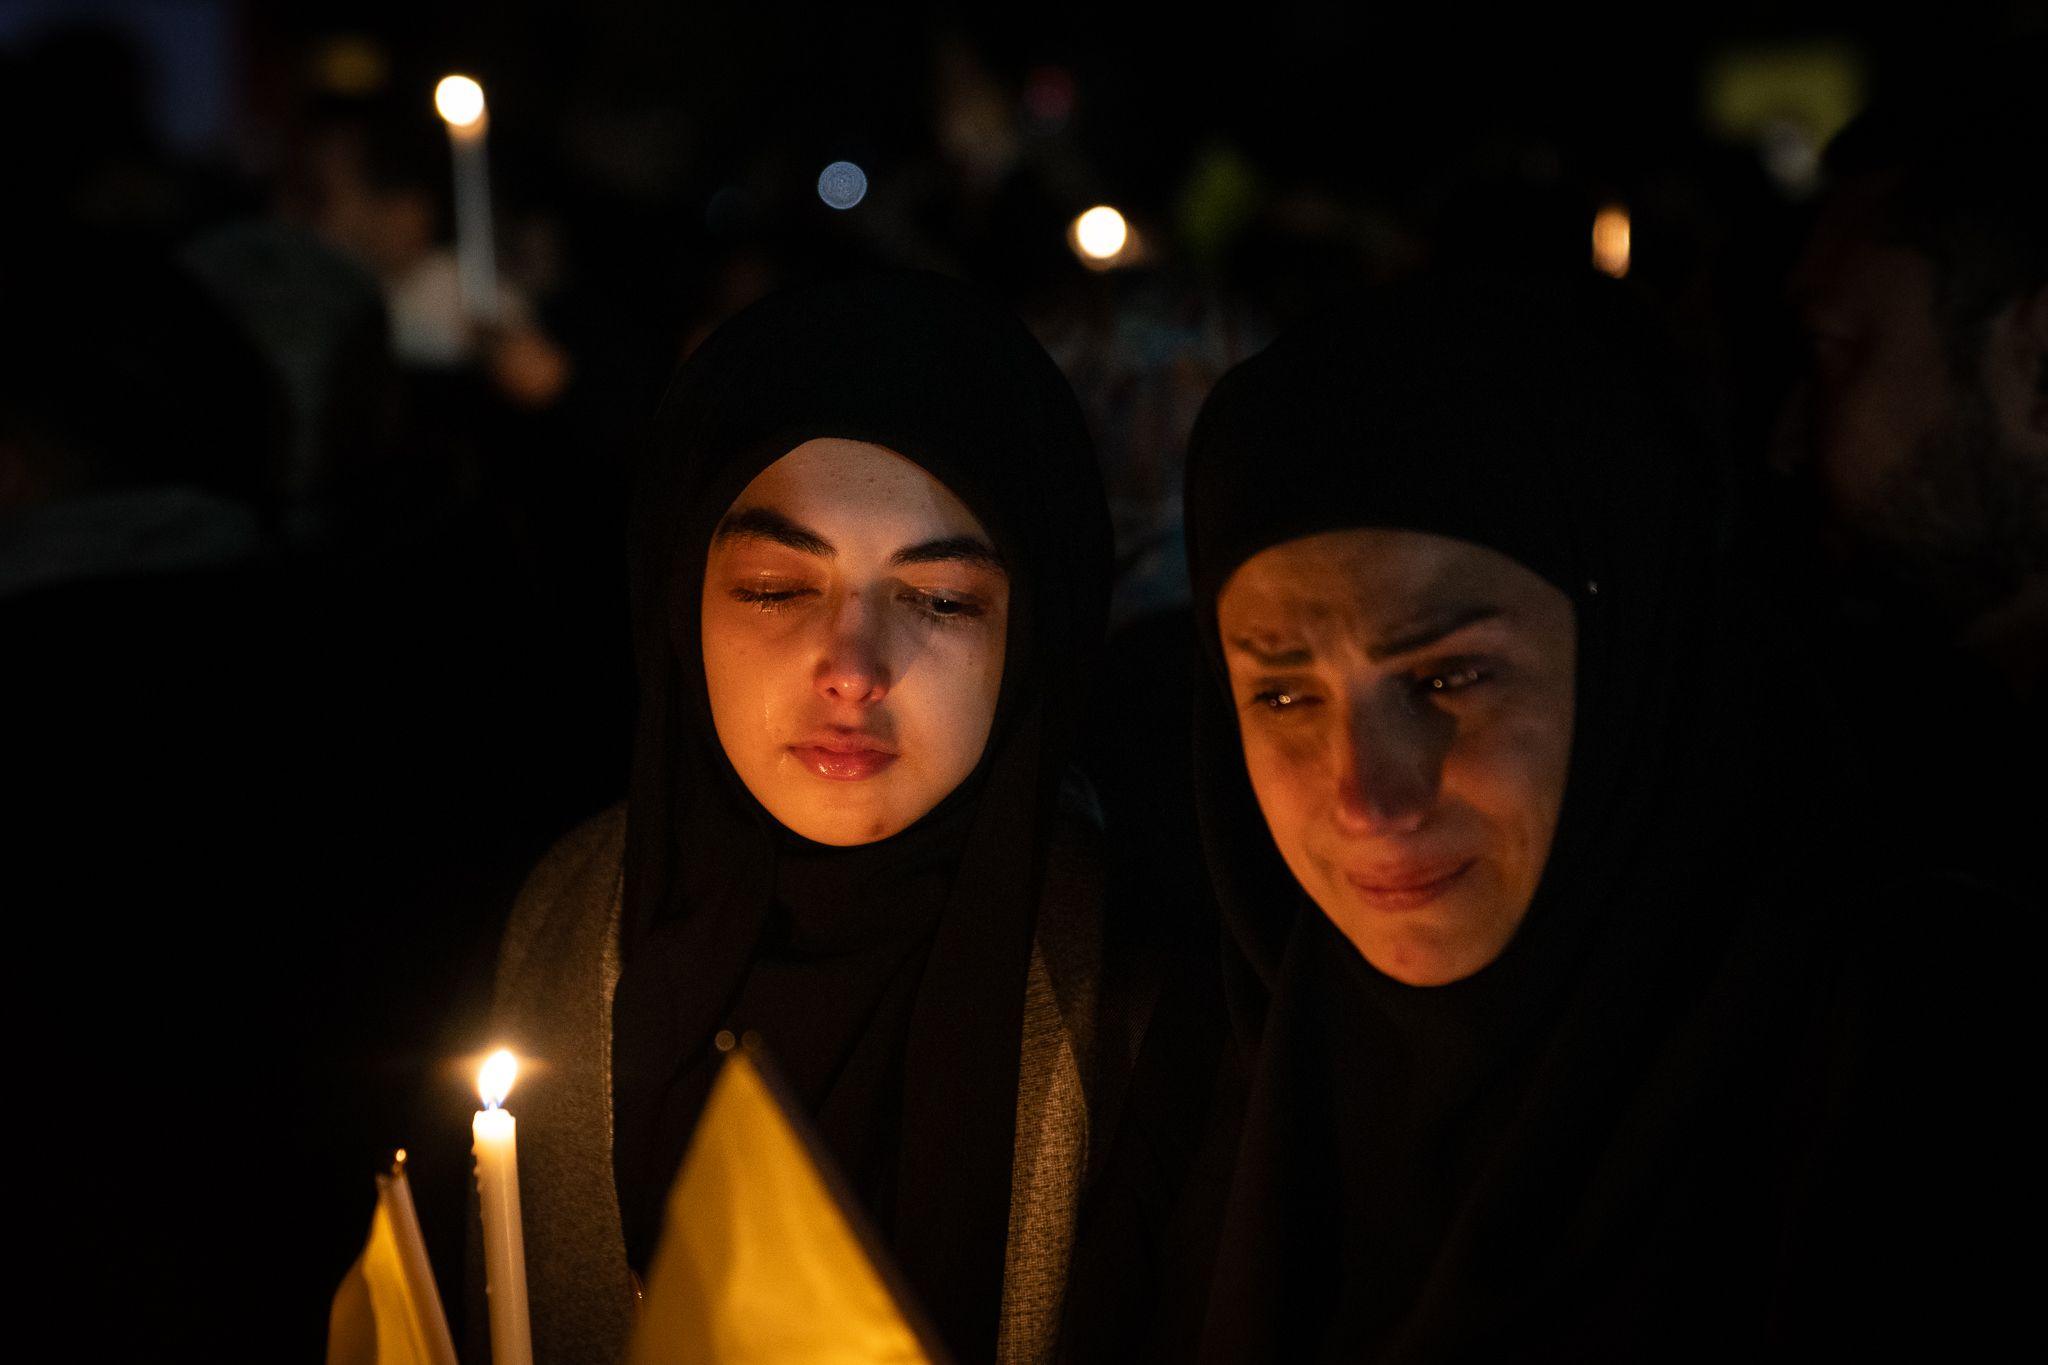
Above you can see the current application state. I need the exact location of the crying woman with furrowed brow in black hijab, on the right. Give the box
[1122,280,1998,1361]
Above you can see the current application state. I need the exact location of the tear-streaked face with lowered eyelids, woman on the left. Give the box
[702,438,1010,845]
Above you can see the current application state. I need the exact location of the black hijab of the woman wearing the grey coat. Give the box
[612,274,1110,1359]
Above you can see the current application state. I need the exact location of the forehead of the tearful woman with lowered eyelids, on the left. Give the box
[729,436,985,538]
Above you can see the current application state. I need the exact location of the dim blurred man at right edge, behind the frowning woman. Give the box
[1782,72,2048,905]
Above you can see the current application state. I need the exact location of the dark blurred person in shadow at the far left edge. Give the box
[0,235,321,1359]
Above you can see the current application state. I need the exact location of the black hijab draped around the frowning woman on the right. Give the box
[1188,278,1875,1361]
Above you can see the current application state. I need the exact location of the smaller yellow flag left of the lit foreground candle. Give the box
[328,1152,455,1365]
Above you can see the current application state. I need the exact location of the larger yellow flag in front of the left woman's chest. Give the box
[629,1048,934,1365]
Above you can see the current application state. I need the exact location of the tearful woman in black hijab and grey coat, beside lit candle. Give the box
[479,274,1110,1361]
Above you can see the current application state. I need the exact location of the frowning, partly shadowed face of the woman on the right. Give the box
[1217,530,1577,986]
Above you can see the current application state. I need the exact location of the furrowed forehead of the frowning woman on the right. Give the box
[1217,528,1563,630]
